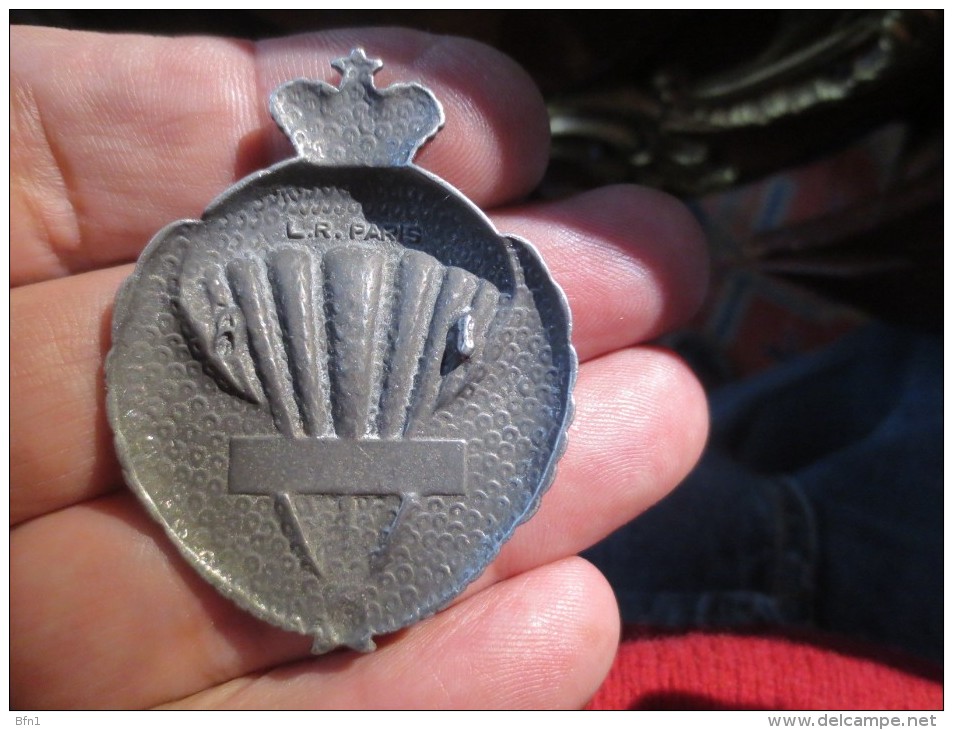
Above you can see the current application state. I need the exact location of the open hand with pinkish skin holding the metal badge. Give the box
[10,27,707,708]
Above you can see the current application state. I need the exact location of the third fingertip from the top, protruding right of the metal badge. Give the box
[468,349,708,594]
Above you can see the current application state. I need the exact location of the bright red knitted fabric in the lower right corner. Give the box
[589,633,943,710]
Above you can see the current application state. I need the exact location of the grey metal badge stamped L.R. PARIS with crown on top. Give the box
[106,49,576,653]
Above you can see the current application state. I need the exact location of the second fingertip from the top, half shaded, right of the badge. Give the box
[494,185,708,352]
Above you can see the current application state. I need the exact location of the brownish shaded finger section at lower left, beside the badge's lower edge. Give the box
[10,492,309,709]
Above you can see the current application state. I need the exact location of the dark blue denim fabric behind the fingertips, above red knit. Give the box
[586,325,943,662]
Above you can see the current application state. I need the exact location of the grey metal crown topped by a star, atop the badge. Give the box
[271,48,444,167]
